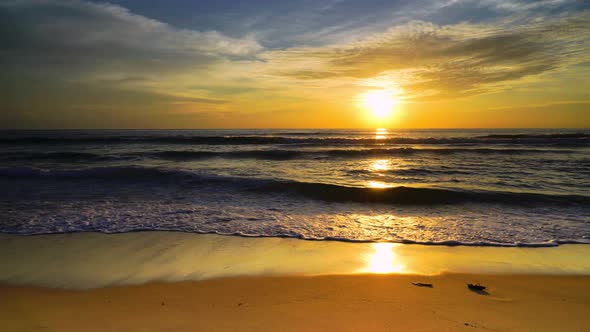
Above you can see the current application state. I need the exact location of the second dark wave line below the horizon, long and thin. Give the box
[0,148,575,162]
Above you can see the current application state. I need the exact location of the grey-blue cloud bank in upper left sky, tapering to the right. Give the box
[0,0,262,85]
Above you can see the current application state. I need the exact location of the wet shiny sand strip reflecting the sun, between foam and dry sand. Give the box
[0,231,590,289]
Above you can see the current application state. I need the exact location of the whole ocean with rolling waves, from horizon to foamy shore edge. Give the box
[0,129,590,246]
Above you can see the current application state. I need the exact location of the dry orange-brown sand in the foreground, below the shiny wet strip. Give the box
[0,274,590,332]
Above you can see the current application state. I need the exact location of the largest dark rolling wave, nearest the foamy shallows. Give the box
[0,166,590,206]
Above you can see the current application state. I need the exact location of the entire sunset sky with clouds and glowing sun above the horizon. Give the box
[0,0,590,129]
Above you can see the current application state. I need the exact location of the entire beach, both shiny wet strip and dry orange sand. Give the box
[0,232,590,331]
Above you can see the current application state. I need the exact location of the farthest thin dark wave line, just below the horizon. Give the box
[0,133,590,146]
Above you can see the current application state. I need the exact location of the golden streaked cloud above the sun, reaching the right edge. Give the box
[264,11,590,99]
